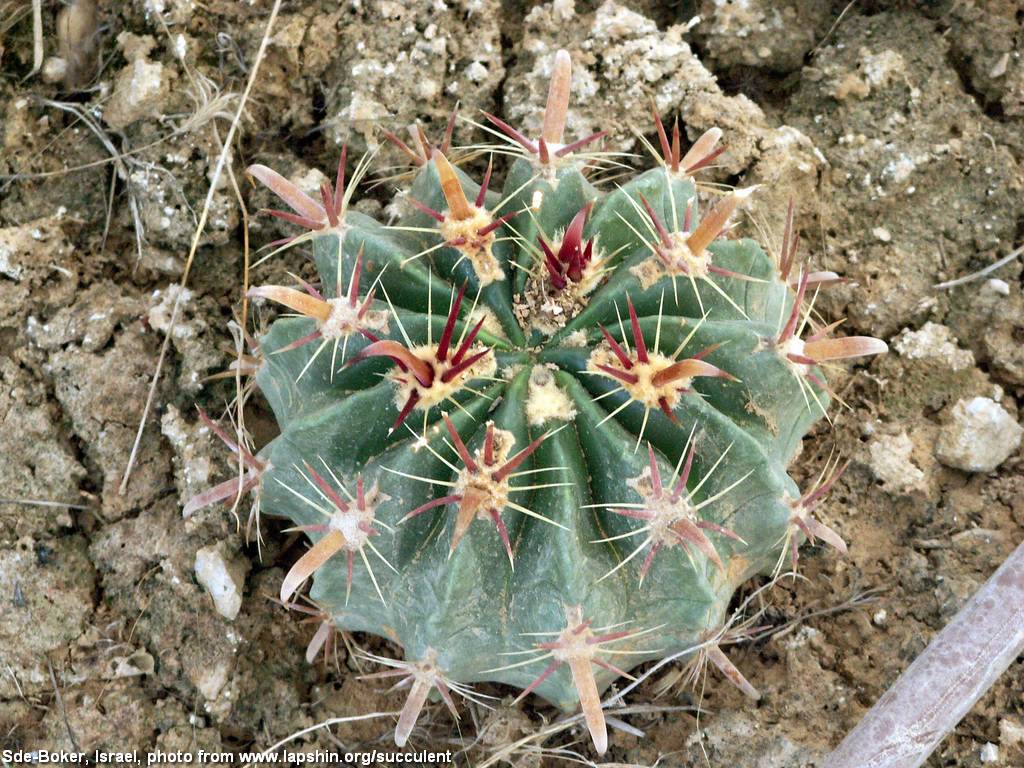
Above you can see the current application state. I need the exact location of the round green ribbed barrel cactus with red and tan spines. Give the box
[190,51,886,753]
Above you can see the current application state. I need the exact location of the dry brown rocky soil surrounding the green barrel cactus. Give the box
[0,0,1024,768]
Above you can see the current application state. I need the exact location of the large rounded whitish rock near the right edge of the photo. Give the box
[935,397,1024,472]
